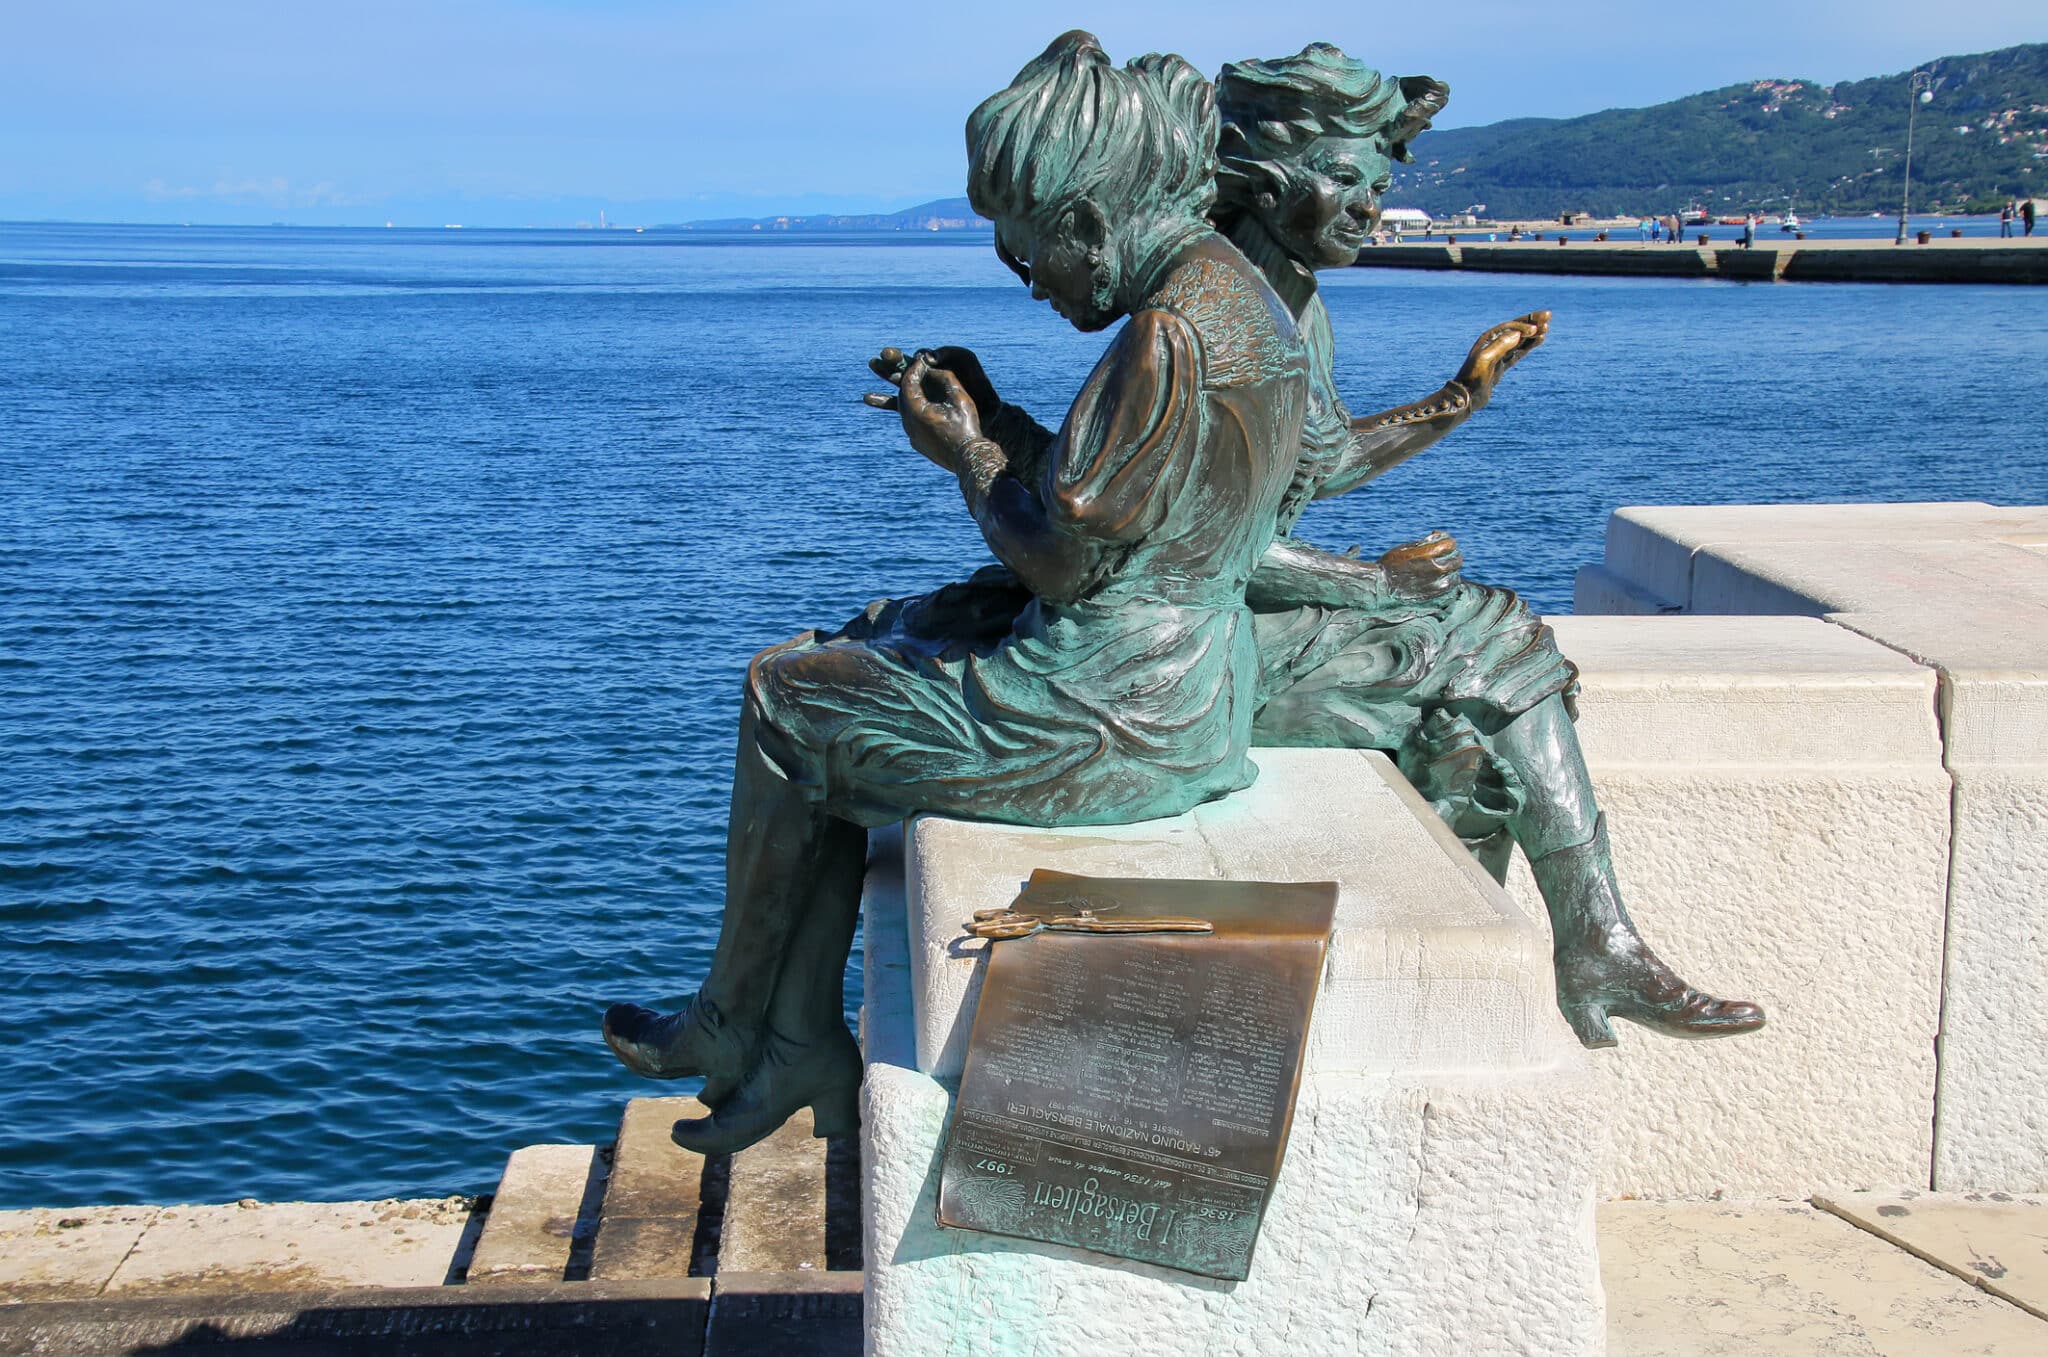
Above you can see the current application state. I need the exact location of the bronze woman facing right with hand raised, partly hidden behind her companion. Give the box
[1217,43,1763,1046]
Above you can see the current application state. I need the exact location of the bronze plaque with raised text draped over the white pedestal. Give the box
[938,870,1337,1281]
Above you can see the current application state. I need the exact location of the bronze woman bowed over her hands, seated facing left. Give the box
[604,33,1307,1152]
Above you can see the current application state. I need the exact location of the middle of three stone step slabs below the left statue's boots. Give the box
[590,1097,727,1281]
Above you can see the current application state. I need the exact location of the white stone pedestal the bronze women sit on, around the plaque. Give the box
[862,749,1606,1357]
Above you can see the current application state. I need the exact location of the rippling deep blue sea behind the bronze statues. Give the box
[0,225,2048,1208]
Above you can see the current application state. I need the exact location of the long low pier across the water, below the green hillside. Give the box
[1358,231,2048,284]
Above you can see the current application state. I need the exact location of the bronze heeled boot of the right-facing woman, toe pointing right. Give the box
[1530,815,1763,1048]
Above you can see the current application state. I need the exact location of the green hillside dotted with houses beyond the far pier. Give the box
[1386,43,2048,217]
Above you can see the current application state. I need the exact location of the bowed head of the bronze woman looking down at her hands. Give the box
[967,33,1217,330]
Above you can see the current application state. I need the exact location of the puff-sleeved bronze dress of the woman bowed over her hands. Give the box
[748,233,1307,827]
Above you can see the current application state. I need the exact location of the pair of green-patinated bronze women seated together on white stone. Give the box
[604,33,1763,1152]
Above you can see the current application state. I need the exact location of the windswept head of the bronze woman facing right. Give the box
[1217,43,1450,268]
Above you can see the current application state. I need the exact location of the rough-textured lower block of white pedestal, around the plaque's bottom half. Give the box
[862,1064,1606,1357]
